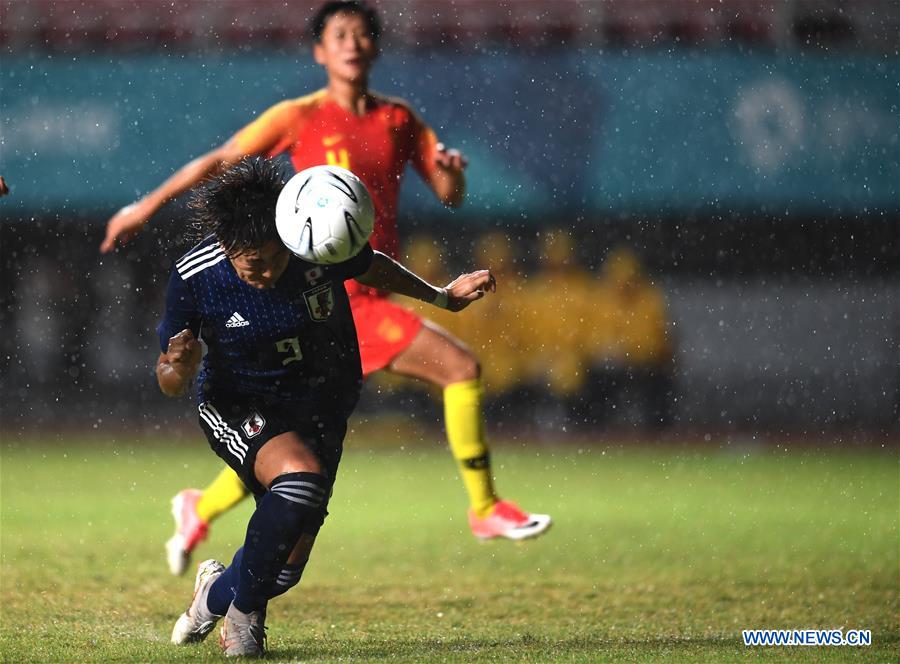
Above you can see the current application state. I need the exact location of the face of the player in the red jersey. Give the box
[313,12,378,82]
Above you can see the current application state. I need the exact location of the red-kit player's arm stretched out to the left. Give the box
[100,103,289,254]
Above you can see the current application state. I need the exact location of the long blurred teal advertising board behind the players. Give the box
[0,50,900,220]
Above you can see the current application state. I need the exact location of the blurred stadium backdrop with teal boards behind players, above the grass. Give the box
[0,0,900,441]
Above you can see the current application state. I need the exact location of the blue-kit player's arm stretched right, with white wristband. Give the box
[356,251,497,311]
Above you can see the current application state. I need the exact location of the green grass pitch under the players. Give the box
[0,436,900,662]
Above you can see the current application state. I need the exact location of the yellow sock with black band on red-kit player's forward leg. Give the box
[444,379,497,517]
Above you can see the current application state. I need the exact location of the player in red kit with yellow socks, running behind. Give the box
[101,0,550,574]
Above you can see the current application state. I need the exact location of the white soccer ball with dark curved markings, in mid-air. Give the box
[275,166,375,265]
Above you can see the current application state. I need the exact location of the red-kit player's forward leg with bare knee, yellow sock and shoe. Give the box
[388,321,550,540]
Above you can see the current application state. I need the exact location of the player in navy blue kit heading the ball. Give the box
[156,158,495,656]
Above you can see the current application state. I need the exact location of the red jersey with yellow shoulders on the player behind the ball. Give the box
[235,89,437,294]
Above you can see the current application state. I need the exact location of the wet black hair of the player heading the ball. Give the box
[188,157,285,256]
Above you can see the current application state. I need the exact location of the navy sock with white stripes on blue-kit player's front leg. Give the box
[232,473,328,613]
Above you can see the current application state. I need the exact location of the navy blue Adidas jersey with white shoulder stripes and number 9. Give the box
[157,237,373,419]
